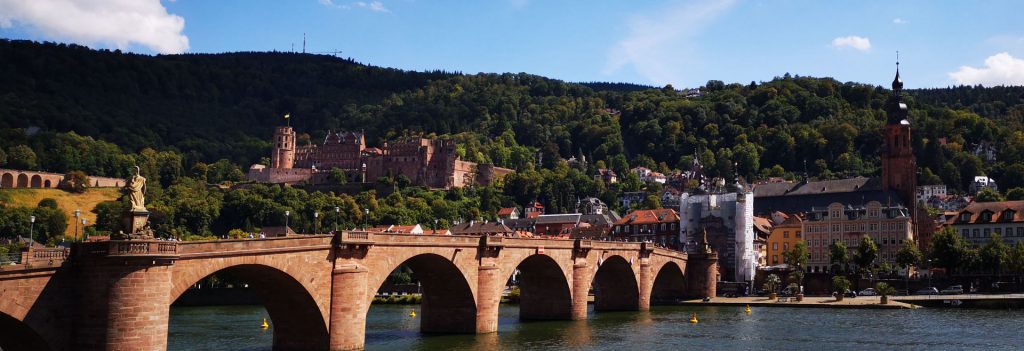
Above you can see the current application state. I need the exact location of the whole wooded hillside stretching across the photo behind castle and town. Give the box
[0,41,1024,195]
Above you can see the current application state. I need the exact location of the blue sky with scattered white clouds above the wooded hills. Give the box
[0,0,1024,88]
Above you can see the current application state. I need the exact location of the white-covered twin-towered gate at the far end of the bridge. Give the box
[679,186,760,281]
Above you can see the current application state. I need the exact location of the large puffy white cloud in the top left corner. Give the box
[0,0,188,53]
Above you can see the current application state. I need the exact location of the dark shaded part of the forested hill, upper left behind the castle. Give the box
[0,40,451,162]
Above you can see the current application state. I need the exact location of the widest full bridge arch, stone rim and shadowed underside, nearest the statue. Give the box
[168,260,330,350]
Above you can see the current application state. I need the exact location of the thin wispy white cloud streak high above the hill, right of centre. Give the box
[603,0,734,84]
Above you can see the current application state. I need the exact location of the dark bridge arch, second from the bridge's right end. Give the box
[591,255,640,311]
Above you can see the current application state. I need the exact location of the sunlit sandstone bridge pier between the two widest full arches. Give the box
[330,264,370,351]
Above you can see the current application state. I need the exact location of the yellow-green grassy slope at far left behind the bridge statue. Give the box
[0,187,121,240]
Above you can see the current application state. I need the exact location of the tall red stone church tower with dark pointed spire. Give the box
[882,61,918,214]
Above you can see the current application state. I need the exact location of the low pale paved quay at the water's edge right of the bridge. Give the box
[679,296,918,309]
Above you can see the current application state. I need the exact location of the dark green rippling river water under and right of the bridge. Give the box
[168,305,1024,351]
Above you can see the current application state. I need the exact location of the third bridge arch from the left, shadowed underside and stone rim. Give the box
[369,253,476,334]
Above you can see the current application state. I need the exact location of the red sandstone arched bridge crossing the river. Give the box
[0,232,717,351]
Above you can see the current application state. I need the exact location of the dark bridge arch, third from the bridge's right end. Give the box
[502,254,572,320]
